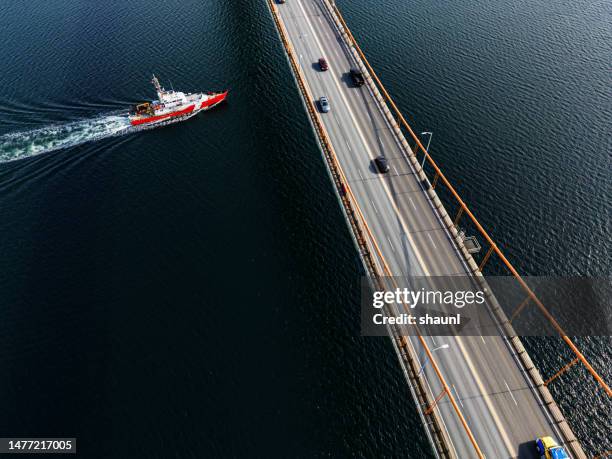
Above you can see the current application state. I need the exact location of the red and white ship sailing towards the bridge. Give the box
[129,75,227,126]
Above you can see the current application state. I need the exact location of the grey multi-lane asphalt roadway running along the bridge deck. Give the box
[276,0,561,458]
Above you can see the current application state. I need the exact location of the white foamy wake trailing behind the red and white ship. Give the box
[0,115,136,163]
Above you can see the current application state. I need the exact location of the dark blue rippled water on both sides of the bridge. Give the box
[0,0,612,458]
